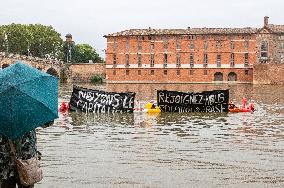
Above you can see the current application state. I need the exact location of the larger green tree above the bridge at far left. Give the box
[0,24,63,58]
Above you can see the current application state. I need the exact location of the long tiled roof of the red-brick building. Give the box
[104,27,258,38]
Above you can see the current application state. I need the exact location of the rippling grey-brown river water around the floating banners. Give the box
[36,84,284,188]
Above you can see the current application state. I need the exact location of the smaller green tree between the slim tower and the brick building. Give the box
[75,44,104,63]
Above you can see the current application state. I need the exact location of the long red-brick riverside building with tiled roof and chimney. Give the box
[104,17,284,83]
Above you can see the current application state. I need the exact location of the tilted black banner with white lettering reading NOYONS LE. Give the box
[70,86,135,113]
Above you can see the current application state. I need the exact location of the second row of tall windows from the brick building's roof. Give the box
[113,53,249,67]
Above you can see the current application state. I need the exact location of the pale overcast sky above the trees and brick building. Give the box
[0,0,284,55]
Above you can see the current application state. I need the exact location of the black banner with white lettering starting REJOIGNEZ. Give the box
[157,90,229,112]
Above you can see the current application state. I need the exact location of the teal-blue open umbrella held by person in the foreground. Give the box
[0,62,58,139]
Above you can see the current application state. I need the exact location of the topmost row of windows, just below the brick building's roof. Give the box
[113,40,249,52]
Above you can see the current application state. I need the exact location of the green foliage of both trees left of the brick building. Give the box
[0,23,104,63]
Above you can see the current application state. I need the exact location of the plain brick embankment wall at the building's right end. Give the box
[253,63,284,84]
